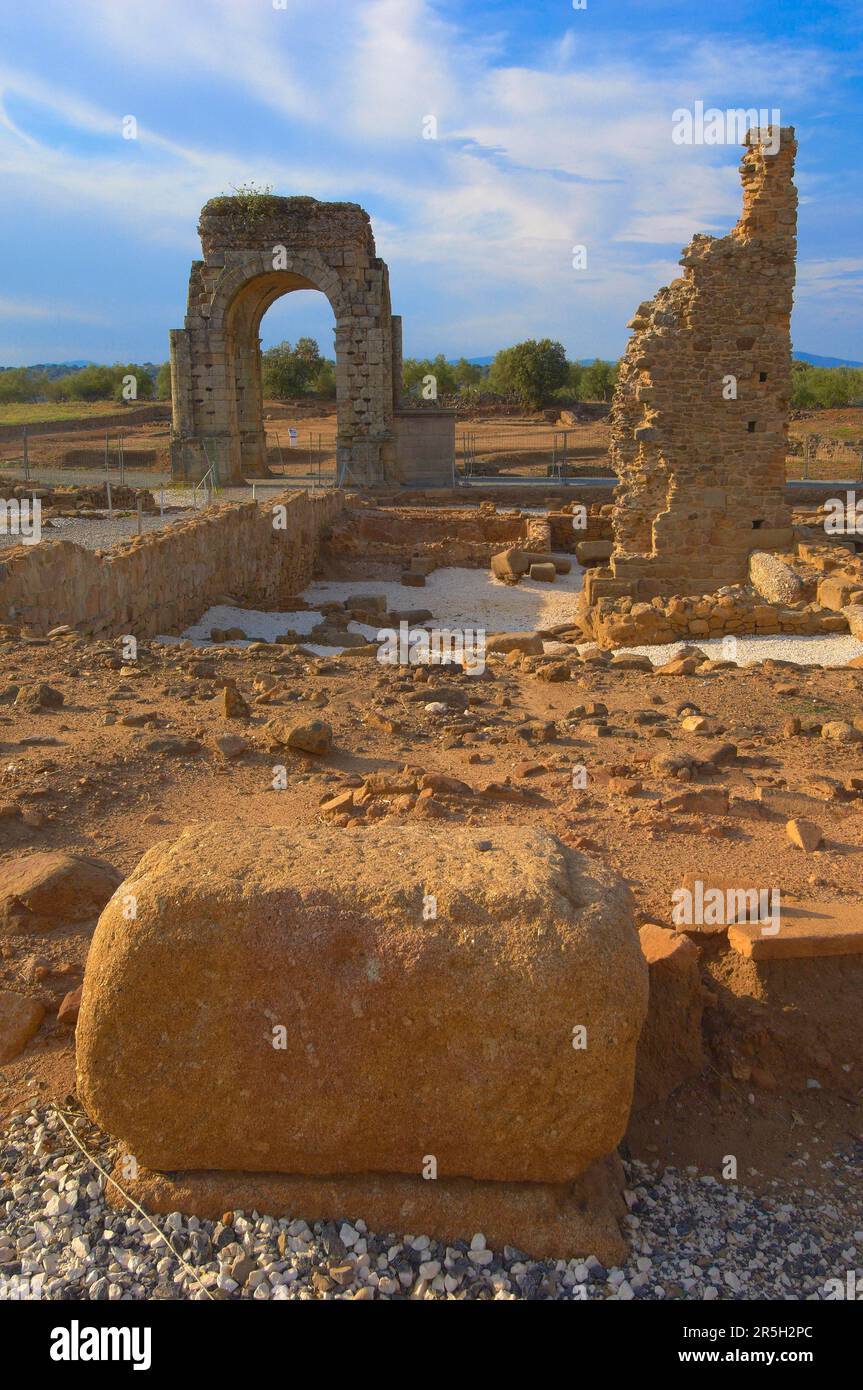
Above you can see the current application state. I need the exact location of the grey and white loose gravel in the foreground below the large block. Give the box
[0,1106,863,1301]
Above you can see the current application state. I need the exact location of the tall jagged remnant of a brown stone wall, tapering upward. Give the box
[585,126,796,603]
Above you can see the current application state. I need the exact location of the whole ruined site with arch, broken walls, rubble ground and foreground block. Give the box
[0,113,863,1302]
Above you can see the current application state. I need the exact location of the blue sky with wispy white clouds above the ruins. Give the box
[0,0,863,366]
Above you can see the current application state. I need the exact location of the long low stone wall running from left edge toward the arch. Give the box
[0,492,345,638]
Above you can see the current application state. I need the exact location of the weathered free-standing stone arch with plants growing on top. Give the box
[171,195,402,485]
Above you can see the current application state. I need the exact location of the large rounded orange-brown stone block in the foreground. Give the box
[78,824,646,1183]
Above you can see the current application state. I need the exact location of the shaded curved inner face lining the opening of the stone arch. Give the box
[225,270,345,478]
